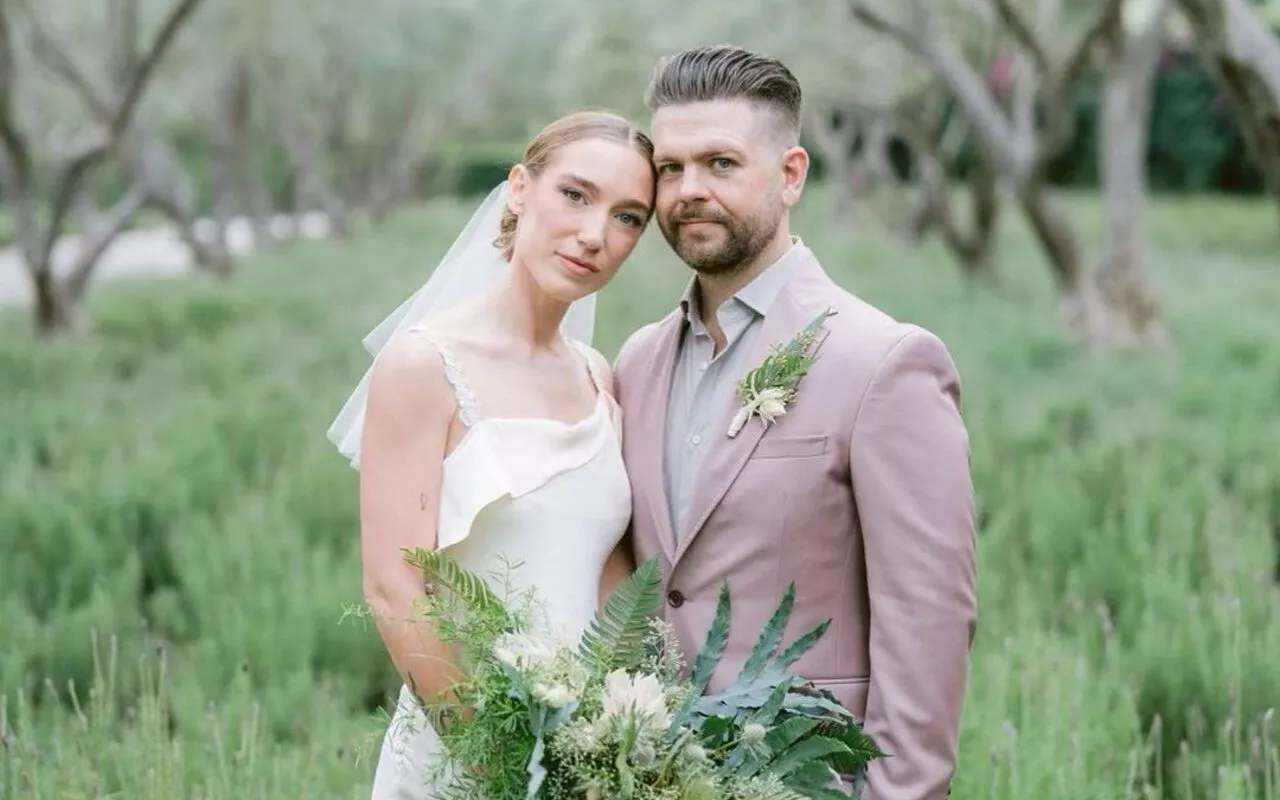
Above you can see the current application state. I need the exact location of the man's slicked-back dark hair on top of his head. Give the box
[645,45,801,143]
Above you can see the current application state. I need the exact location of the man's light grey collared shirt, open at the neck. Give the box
[662,238,808,543]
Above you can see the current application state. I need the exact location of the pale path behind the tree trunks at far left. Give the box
[0,214,329,307]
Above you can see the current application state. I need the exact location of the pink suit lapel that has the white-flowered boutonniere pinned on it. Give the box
[662,288,829,567]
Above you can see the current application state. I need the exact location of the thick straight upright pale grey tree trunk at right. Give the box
[1097,5,1167,346]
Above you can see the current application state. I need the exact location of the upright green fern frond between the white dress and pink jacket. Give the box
[579,556,662,673]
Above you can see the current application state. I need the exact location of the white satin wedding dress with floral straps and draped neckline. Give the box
[372,326,631,800]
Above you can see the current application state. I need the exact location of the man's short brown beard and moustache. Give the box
[662,204,782,275]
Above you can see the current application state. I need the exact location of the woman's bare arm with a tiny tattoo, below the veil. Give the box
[360,335,458,701]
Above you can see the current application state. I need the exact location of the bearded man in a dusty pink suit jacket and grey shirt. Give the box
[614,46,977,800]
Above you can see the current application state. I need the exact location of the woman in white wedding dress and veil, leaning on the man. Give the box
[329,111,655,800]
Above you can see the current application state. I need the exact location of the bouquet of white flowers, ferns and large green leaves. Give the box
[396,549,882,800]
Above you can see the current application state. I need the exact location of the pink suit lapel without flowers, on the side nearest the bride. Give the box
[635,311,684,561]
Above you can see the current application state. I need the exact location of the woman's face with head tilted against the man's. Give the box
[511,138,654,302]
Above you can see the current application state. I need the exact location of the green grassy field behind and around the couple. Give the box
[0,186,1280,800]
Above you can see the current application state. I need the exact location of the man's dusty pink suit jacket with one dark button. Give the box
[614,248,977,800]
